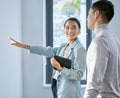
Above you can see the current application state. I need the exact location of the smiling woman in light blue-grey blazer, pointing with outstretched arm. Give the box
[9,18,86,98]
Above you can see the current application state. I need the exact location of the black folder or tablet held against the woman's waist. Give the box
[54,55,72,69]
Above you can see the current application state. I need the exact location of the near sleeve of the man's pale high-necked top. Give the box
[84,38,109,98]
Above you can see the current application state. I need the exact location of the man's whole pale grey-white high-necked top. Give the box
[84,24,120,98]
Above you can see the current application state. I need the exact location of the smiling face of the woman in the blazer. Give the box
[65,20,80,41]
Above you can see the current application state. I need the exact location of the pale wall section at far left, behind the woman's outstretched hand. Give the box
[0,0,22,98]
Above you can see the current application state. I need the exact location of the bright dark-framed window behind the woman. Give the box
[45,0,91,84]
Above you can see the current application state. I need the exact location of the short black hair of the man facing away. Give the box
[91,0,114,22]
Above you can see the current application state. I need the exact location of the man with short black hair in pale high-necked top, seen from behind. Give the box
[84,0,120,98]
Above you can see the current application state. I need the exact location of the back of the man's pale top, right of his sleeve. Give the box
[100,27,120,98]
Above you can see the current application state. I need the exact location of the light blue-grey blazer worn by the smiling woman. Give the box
[30,39,86,98]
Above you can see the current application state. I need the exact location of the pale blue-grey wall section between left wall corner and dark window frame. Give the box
[22,0,52,98]
